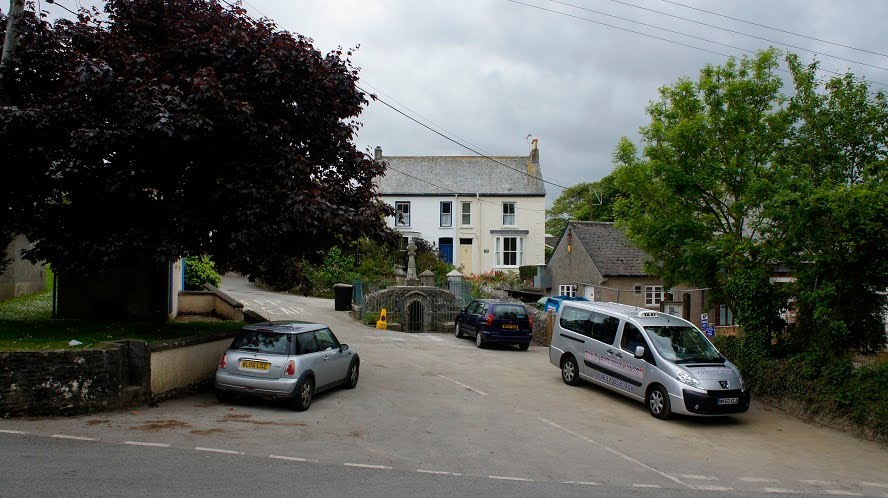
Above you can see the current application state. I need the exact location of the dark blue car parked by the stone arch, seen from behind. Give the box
[454,299,533,351]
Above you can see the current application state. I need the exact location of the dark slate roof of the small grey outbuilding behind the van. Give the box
[562,221,650,277]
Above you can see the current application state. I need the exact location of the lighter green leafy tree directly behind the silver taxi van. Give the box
[614,49,792,354]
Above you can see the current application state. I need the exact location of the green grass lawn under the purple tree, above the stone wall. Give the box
[0,271,244,350]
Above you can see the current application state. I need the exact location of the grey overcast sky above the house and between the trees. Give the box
[44,0,888,204]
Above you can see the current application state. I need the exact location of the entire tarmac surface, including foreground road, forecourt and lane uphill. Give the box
[0,276,888,496]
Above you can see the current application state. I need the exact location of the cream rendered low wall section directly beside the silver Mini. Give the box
[150,332,237,401]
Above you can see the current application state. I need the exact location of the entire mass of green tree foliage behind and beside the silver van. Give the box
[613,49,888,357]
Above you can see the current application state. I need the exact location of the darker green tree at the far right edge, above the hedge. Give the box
[767,56,888,353]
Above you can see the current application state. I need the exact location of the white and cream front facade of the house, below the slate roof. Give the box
[381,195,546,274]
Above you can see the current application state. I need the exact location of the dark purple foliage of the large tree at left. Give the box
[0,0,390,276]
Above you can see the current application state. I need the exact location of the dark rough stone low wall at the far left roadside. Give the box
[0,346,127,417]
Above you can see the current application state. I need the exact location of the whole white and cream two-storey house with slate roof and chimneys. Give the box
[376,140,546,274]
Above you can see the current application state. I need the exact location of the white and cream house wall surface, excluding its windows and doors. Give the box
[382,195,546,274]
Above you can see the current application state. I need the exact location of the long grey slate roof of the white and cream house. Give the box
[376,156,546,196]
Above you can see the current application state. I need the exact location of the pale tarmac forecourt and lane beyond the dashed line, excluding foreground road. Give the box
[0,276,888,496]
